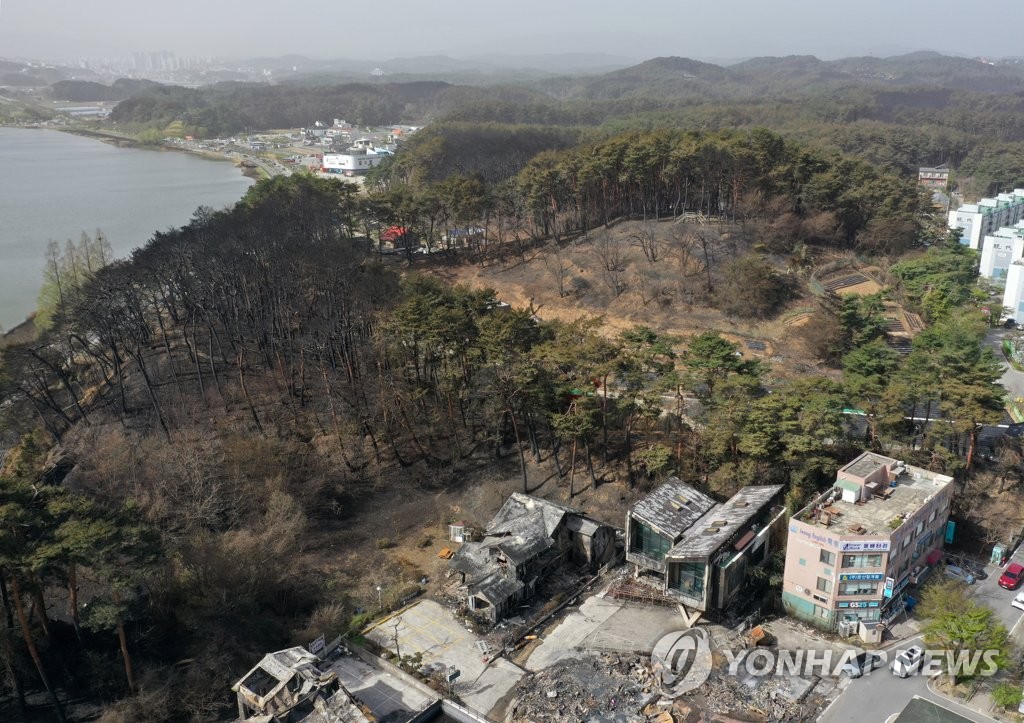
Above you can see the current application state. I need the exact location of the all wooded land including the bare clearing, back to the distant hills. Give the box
[6,49,1024,723]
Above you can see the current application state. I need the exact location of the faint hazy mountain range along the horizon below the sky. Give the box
[8,51,1024,100]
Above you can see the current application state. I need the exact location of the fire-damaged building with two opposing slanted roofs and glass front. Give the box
[626,478,784,611]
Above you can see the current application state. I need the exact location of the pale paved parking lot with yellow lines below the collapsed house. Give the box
[367,600,524,714]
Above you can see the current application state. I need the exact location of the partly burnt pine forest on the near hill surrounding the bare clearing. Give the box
[0,132,1001,721]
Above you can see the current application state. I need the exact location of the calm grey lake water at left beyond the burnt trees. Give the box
[0,128,252,329]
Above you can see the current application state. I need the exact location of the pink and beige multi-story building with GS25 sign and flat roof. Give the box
[782,452,953,632]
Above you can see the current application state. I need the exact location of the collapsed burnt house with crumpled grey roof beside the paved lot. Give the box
[449,493,615,623]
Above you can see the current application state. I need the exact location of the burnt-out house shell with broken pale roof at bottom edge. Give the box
[231,647,369,723]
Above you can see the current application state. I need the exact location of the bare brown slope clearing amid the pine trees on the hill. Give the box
[431,221,820,378]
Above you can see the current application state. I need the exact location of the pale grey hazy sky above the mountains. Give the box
[0,0,1024,59]
